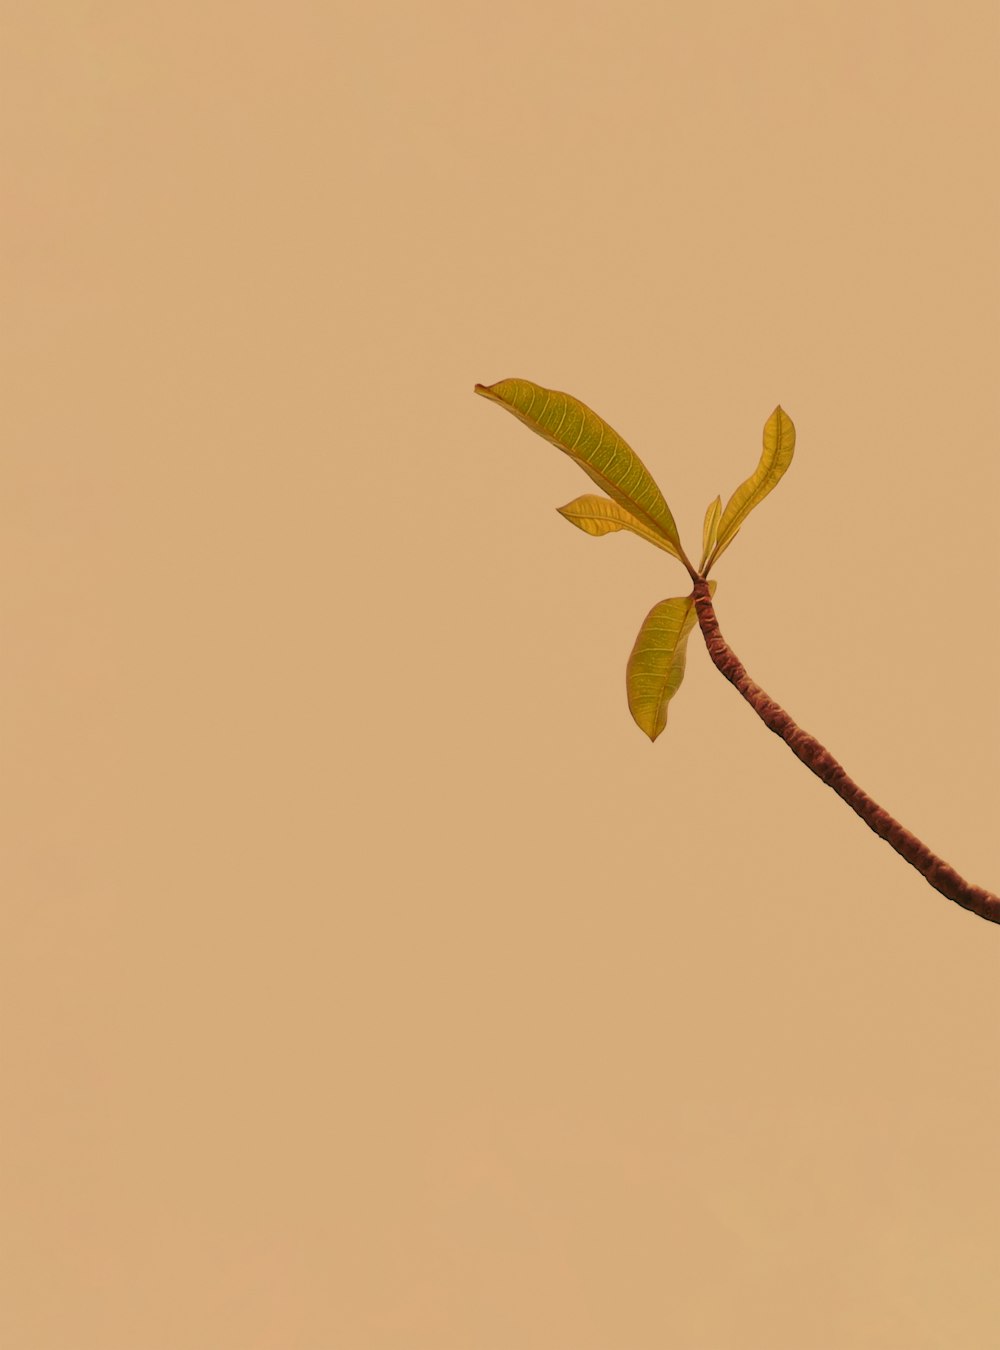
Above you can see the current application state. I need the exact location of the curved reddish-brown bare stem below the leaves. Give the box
[694,579,1000,923]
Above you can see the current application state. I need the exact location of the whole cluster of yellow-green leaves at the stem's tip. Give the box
[475,379,795,741]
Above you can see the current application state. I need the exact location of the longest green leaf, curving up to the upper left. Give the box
[475,379,686,562]
